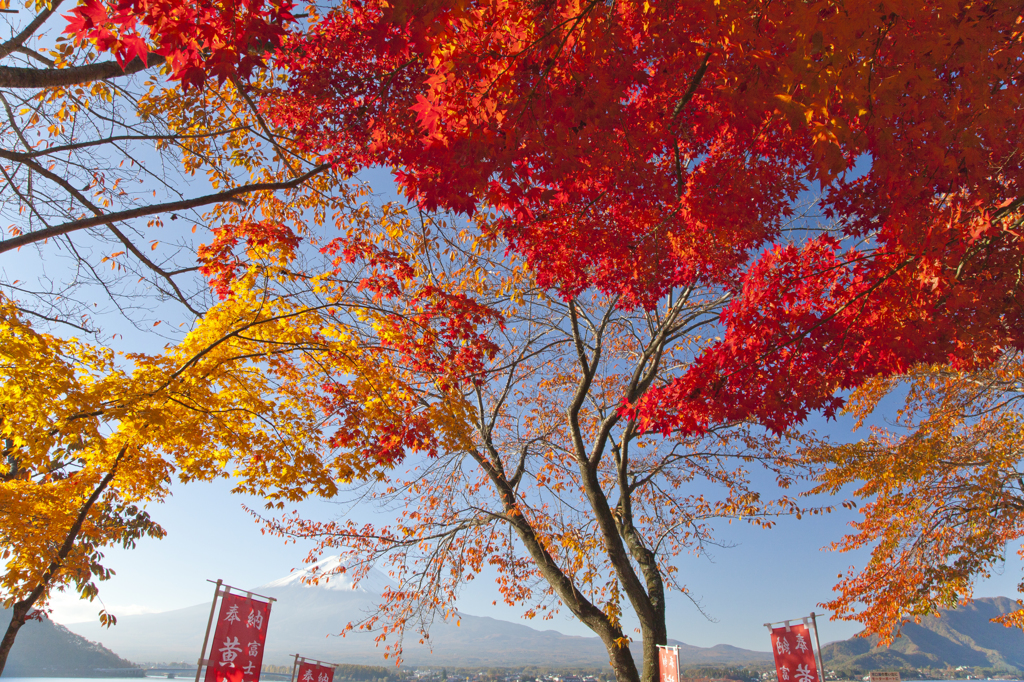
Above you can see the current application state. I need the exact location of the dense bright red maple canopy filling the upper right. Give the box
[64,0,1024,431]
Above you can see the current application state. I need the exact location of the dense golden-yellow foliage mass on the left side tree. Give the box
[0,290,380,607]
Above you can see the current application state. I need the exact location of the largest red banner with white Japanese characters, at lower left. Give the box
[206,593,270,682]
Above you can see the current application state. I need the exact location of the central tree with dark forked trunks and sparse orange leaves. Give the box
[253,215,820,680]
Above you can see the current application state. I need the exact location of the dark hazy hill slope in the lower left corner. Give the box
[0,610,139,677]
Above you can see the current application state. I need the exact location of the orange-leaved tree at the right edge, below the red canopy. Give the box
[807,351,1024,643]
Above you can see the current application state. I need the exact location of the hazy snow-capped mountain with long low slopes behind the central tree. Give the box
[69,560,771,667]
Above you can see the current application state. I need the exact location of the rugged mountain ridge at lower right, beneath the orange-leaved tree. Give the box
[821,597,1024,673]
